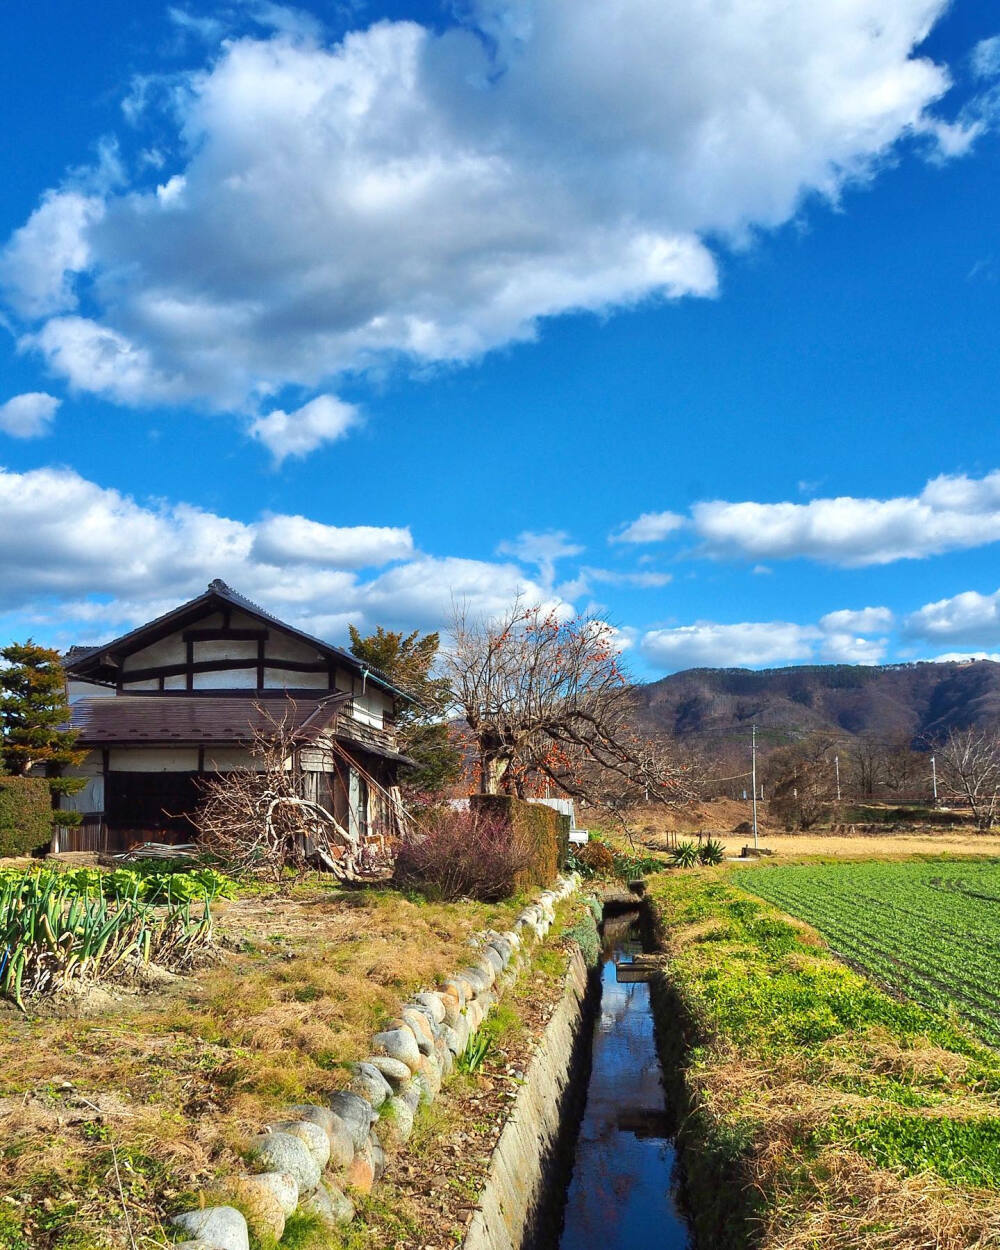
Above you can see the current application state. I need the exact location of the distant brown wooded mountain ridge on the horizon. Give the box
[636,660,1000,743]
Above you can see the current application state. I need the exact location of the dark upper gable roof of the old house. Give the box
[63,578,416,703]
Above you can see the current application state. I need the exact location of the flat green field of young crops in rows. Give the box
[735,860,1000,1046]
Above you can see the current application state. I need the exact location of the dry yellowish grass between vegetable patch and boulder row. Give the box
[0,884,515,1250]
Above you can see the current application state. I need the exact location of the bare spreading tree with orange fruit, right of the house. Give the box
[448,600,686,805]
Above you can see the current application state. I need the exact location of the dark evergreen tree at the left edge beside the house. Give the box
[0,639,86,825]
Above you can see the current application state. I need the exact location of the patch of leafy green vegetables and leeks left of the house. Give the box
[0,869,234,1010]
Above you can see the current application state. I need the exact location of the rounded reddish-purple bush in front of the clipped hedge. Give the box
[395,808,533,903]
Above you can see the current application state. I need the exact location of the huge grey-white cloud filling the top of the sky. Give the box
[0,0,954,435]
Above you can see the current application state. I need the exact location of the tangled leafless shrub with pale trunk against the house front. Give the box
[194,715,395,881]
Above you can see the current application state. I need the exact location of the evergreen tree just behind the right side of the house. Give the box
[350,625,463,794]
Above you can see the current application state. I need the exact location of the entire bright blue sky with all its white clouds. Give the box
[0,0,1000,678]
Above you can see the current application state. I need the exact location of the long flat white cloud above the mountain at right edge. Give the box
[691,470,1000,568]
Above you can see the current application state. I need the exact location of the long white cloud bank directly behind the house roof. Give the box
[0,469,558,636]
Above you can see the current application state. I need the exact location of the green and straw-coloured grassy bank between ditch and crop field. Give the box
[650,870,1000,1250]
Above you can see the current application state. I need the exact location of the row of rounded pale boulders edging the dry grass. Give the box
[173,876,586,1250]
